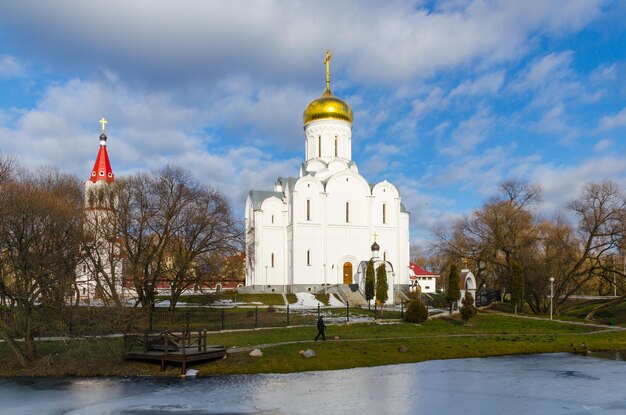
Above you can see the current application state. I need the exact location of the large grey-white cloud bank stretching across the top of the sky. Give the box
[0,0,601,84]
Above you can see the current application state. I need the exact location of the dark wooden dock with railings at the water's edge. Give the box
[124,331,226,375]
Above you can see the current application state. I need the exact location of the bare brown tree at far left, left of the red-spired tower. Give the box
[0,169,83,366]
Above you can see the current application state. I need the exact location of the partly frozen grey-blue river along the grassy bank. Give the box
[0,354,626,415]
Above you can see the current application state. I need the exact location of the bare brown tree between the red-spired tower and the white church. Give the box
[118,167,243,308]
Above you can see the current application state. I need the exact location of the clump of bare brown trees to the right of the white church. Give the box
[436,181,626,313]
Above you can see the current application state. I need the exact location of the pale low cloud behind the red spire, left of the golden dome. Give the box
[0,80,300,210]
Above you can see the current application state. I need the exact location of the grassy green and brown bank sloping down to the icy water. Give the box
[0,313,626,377]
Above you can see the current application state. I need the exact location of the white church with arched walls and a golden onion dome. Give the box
[245,52,410,303]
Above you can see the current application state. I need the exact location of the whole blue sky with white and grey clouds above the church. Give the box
[0,0,626,250]
